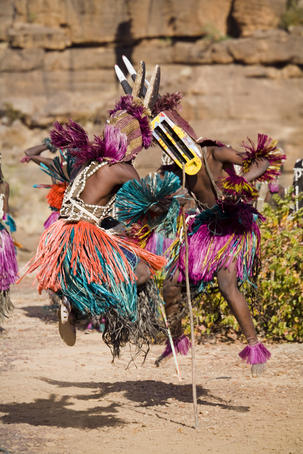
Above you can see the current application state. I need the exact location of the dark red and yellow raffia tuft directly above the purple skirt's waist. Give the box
[218,169,258,201]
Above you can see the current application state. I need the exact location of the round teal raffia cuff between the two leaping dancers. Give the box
[116,172,181,233]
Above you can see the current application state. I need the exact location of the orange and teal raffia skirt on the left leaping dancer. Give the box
[19,219,166,320]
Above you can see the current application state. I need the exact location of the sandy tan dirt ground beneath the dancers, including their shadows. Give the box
[0,278,303,454]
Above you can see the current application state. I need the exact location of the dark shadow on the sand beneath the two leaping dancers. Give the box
[0,378,249,429]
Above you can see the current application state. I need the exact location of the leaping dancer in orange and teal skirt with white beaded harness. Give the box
[19,64,166,356]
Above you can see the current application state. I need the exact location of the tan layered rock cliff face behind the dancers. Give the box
[0,0,303,188]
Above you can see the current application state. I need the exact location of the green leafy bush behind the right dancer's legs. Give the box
[185,189,303,342]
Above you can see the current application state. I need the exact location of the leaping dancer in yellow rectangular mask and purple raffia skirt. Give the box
[113,57,285,374]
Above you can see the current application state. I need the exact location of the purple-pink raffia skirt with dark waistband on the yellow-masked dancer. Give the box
[179,202,264,284]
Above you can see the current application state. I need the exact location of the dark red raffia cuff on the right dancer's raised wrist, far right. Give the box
[242,134,286,181]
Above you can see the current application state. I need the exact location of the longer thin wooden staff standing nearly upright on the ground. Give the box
[181,164,199,429]
